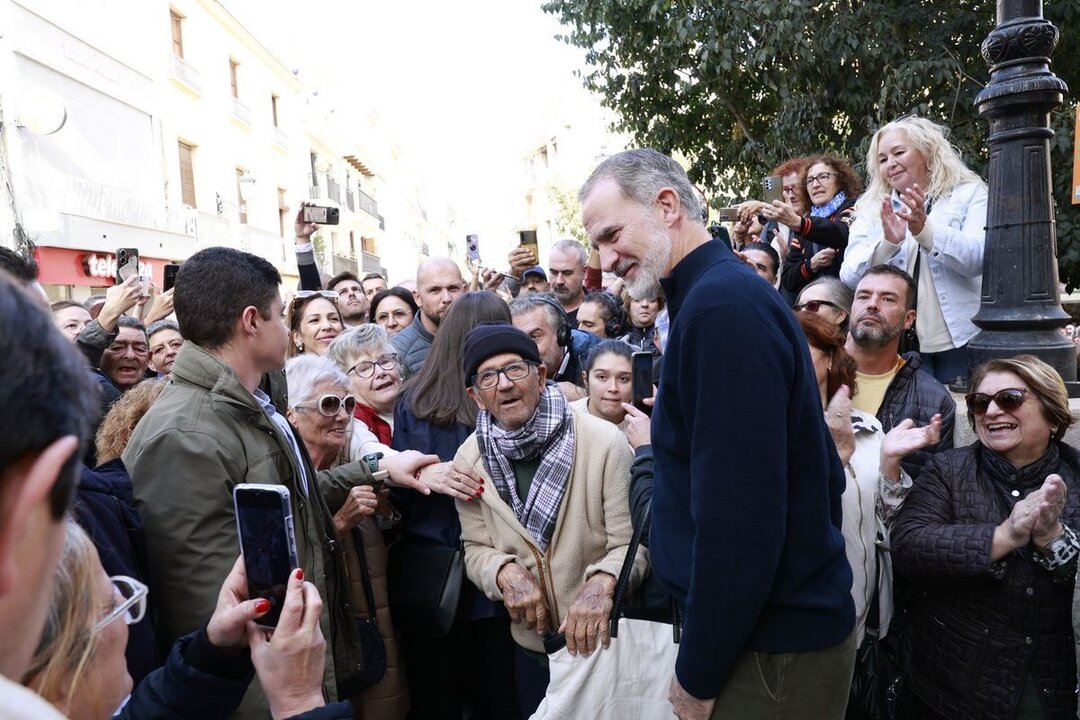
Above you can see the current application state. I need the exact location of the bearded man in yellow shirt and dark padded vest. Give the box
[845,264,956,479]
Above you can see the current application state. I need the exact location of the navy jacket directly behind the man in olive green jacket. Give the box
[75,458,161,684]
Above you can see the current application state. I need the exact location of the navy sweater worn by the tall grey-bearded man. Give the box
[649,241,854,698]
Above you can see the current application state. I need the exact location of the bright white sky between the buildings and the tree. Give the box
[234,0,600,249]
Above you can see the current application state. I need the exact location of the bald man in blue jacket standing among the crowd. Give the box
[390,257,465,377]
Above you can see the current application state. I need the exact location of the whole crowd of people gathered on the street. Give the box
[0,117,1080,720]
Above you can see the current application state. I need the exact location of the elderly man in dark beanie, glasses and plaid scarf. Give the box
[455,323,647,717]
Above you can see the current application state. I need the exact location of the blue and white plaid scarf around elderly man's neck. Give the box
[476,383,575,553]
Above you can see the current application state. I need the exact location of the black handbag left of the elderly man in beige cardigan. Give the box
[387,542,465,638]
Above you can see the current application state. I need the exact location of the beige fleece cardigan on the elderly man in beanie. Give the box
[455,409,648,652]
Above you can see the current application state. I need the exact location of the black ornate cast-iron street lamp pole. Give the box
[968,0,1077,386]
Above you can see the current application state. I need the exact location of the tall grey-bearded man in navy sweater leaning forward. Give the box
[580,150,855,720]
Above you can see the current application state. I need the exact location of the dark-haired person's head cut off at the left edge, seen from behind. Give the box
[0,270,97,720]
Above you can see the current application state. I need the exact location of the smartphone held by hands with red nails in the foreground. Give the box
[232,483,300,627]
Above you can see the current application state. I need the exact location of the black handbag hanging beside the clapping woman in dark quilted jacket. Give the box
[845,551,901,720]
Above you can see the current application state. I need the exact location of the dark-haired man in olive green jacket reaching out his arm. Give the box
[123,247,434,718]
